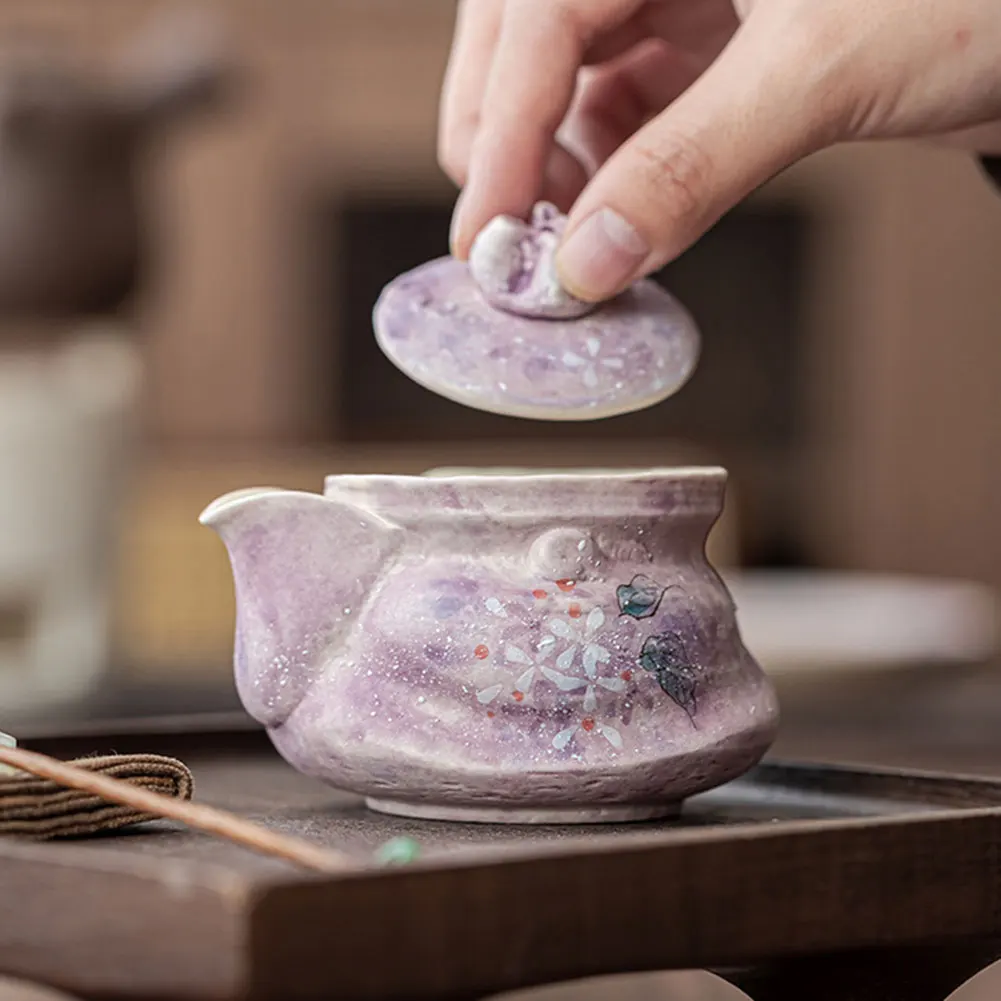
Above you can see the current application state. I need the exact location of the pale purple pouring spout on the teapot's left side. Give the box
[199,487,402,727]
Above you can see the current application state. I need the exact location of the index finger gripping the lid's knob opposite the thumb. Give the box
[453,0,643,255]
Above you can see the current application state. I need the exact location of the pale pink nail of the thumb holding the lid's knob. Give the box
[557,208,650,301]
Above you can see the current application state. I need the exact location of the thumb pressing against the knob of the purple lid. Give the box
[557,11,838,302]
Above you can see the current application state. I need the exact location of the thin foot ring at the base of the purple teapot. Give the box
[365,796,682,825]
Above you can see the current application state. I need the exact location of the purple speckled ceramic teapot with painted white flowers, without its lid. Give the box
[202,468,778,823]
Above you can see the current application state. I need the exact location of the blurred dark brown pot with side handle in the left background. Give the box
[0,10,228,318]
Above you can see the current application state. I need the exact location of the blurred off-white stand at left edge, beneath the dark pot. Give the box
[0,328,142,713]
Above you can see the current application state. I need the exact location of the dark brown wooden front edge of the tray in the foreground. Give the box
[0,744,1001,1001]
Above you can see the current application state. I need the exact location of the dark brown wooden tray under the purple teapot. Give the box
[0,717,1001,1001]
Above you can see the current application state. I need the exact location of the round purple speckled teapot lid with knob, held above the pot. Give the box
[373,209,700,420]
